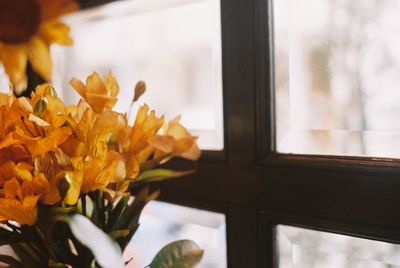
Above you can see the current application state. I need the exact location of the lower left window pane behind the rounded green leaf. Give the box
[124,201,227,268]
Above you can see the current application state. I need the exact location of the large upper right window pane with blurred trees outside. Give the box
[274,0,400,158]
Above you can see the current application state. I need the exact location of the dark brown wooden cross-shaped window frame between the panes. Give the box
[76,0,400,268]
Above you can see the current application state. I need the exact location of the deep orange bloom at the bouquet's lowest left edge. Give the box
[0,178,39,225]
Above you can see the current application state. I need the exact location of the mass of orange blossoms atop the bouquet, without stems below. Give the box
[0,71,200,224]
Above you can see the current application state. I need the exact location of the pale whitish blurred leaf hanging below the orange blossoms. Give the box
[68,214,124,268]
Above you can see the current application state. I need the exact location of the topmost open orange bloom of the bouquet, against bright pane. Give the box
[70,72,119,113]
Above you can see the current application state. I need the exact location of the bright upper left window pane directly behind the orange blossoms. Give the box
[52,0,223,150]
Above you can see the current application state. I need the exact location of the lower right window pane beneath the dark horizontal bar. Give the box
[277,225,400,268]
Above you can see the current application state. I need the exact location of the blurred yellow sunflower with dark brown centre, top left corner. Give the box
[0,0,77,94]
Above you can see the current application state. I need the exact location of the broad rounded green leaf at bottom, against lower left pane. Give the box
[149,240,204,268]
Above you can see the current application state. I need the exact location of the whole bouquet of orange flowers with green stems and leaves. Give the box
[0,73,203,267]
